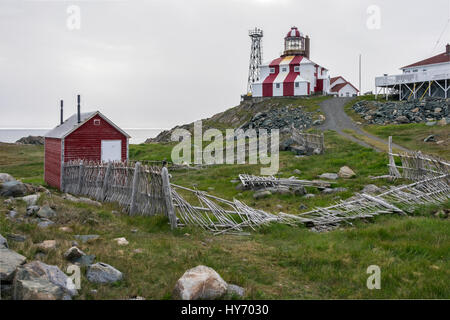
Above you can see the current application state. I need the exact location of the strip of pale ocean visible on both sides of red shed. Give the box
[0,128,164,144]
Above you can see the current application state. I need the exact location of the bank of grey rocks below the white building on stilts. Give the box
[352,97,450,125]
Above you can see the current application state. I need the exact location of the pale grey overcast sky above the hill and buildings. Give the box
[0,0,450,128]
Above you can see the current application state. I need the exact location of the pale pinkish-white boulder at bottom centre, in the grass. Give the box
[173,265,228,300]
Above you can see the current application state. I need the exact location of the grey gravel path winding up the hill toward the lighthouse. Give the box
[318,98,409,152]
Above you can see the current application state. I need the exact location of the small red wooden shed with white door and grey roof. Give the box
[44,111,130,188]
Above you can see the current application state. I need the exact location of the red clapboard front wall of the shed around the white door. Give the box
[64,115,127,161]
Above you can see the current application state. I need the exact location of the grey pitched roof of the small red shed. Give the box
[44,111,130,139]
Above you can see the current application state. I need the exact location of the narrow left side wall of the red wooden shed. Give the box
[44,138,61,188]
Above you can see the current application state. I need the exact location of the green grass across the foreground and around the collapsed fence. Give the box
[0,132,450,299]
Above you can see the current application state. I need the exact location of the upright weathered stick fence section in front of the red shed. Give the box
[61,160,177,228]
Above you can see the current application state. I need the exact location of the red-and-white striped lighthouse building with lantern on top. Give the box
[252,27,330,97]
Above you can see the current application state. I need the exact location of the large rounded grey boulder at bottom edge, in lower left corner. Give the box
[13,261,78,300]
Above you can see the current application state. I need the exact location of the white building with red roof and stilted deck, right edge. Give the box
[375,44,450,100]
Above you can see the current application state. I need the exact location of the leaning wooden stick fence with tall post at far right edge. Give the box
[388,137,450,181]
